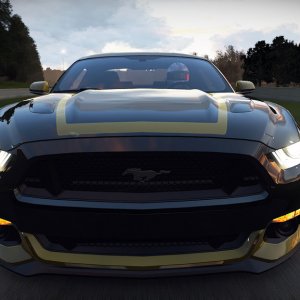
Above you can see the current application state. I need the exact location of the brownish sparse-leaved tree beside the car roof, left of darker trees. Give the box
[213,45,244,86]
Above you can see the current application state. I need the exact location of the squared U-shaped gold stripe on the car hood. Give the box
[56,95,228,136]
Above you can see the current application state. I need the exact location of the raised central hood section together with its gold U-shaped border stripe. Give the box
[56,90,227,136]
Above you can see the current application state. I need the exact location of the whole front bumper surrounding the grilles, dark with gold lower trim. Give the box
[0,138,300,277]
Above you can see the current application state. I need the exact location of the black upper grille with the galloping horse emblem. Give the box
[22,152,264,197]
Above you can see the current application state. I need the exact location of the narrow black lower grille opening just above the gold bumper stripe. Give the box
[37,233,249,256]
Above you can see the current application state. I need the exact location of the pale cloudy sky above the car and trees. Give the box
[10,0,300,69]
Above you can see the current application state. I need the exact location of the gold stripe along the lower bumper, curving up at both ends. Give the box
[24,232,258,268]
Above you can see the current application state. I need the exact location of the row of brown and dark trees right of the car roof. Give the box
[213,36,300,86]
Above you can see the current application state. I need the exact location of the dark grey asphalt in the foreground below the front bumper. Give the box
[0,250,300,300]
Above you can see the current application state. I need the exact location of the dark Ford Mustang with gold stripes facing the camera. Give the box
[0,53,300,277]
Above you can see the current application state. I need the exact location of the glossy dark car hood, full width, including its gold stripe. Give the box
[0,89,299,150]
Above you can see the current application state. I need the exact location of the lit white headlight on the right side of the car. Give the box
[272,142,300,170]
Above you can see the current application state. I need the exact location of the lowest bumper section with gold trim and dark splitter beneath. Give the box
[0,225,300,277]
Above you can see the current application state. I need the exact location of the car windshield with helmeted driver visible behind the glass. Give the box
[52,55,232,93]
